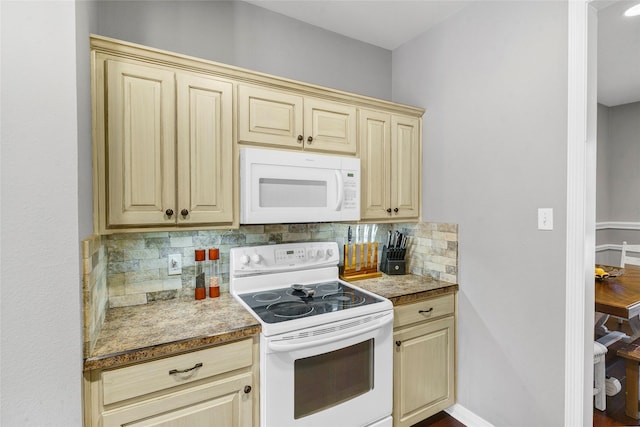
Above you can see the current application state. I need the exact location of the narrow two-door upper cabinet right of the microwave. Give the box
[359,109,422,221]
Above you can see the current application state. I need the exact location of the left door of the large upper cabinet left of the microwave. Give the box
[106,60,176,226]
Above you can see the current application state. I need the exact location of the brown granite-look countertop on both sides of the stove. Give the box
[84,274,458,371]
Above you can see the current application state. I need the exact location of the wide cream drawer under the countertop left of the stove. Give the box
[102,340,253,405]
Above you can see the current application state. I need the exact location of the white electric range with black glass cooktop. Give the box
[229,242,393,427]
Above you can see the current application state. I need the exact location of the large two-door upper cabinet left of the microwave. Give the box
[93,54,234,232]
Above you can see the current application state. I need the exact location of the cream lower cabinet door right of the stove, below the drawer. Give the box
[393,316,455,427]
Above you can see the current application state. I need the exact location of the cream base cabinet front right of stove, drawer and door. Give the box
[393,294,455,427]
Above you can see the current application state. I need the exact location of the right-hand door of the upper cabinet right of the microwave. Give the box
[391,116,422,219]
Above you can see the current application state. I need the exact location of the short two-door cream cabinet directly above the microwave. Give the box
[238,85,357,155]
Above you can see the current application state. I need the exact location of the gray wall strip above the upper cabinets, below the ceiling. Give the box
[98,1,391,100]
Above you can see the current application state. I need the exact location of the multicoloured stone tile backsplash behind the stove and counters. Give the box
[82,222,458,351]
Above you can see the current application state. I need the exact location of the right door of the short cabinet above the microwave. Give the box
[304,98,357,154]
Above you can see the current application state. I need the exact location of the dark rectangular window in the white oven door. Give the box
[294,338,374,419]
